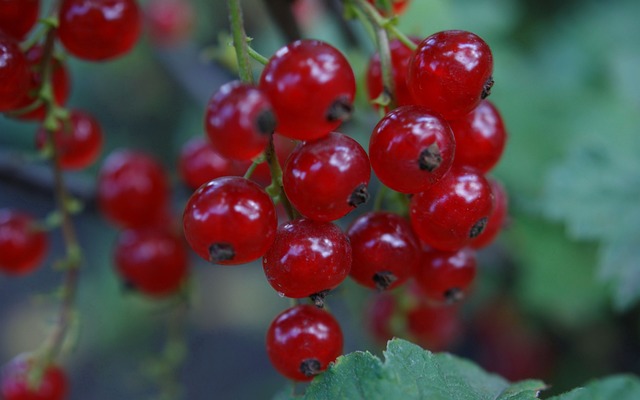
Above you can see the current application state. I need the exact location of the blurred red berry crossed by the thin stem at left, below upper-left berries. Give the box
[36,110,102,169]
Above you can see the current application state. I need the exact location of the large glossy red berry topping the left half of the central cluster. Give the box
[260,39,356,140]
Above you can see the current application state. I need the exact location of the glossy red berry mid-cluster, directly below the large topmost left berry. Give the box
[282,132,371,221]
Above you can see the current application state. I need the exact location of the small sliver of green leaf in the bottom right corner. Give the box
[549,375,640,400]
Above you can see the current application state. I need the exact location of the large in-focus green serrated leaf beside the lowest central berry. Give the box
[303,339,545,400]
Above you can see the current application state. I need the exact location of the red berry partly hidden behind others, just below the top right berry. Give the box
[449,100,507,174]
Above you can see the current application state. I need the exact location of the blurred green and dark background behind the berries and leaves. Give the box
[0,0,640,400]
